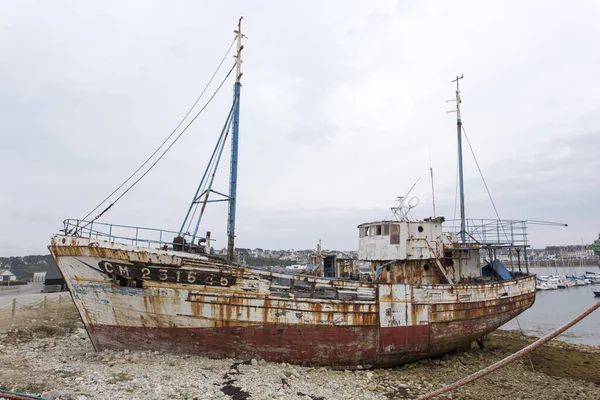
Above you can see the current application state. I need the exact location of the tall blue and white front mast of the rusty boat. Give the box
[227,17,244,262]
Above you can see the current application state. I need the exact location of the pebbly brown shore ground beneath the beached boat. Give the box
[0,309,600,400]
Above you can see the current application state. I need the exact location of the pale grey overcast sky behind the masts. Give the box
[0,0,600,256]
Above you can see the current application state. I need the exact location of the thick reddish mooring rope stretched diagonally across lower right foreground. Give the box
[417,301,600,400]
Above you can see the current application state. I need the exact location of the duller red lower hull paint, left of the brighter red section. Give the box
[89,325,378,367]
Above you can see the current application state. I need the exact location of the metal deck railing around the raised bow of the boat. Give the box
[58,219,193,250]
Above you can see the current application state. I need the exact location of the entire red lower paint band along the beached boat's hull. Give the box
[89,302,523,368]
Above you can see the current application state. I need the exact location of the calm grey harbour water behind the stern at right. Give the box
[500,267,600,346]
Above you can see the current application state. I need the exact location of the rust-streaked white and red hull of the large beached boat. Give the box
[50,235,535,368]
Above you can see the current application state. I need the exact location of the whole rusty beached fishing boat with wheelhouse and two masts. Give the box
[50,21,536,368]
